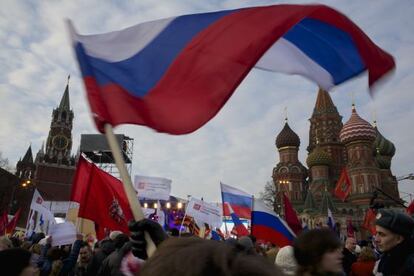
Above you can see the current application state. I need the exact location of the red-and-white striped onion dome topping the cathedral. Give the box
[339,105,377,144]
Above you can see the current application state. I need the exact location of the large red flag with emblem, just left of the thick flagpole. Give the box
[71,157,133,239]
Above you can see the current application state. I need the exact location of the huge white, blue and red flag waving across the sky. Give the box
[69,5,395,134]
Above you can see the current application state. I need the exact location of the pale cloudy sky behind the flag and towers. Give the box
[0,0,414,205]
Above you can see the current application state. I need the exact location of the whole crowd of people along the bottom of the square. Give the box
[0,209,414,276]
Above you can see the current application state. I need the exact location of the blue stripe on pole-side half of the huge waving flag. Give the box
[76,10,235,97]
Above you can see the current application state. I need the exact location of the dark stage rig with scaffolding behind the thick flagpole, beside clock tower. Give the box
[80,134,134,178]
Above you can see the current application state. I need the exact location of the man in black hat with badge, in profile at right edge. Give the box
[373,209,414,275]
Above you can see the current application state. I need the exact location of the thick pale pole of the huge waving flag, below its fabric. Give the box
[105,124,157,257]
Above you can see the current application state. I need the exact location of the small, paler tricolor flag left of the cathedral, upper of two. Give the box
[220,183,253,219]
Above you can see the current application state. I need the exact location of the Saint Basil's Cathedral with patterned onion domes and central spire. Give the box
[272,90,401,235]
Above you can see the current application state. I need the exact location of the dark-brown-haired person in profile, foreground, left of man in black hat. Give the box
[293,228,343,276]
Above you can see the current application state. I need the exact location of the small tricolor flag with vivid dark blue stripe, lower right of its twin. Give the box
[251,199,296,247]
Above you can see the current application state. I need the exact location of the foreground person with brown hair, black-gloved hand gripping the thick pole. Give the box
[129,219,282,276]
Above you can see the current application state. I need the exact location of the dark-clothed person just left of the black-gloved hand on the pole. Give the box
[98,233,131,276]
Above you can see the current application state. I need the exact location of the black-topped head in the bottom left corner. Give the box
[0,248,37,276]
